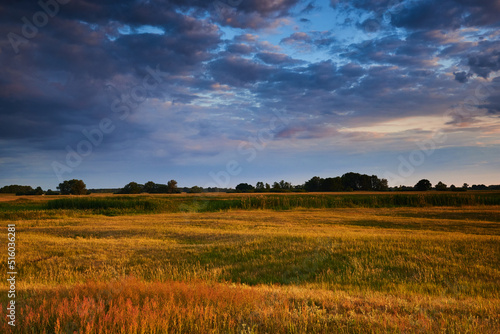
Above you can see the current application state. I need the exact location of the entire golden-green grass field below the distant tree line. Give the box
[0,192,500,333]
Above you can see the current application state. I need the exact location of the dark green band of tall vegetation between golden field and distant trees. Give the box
[0,192,500,220]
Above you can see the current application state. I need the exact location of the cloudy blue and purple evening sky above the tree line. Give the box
[0,0,500,189]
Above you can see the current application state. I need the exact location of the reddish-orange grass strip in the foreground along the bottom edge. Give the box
[0,278,500,333]
